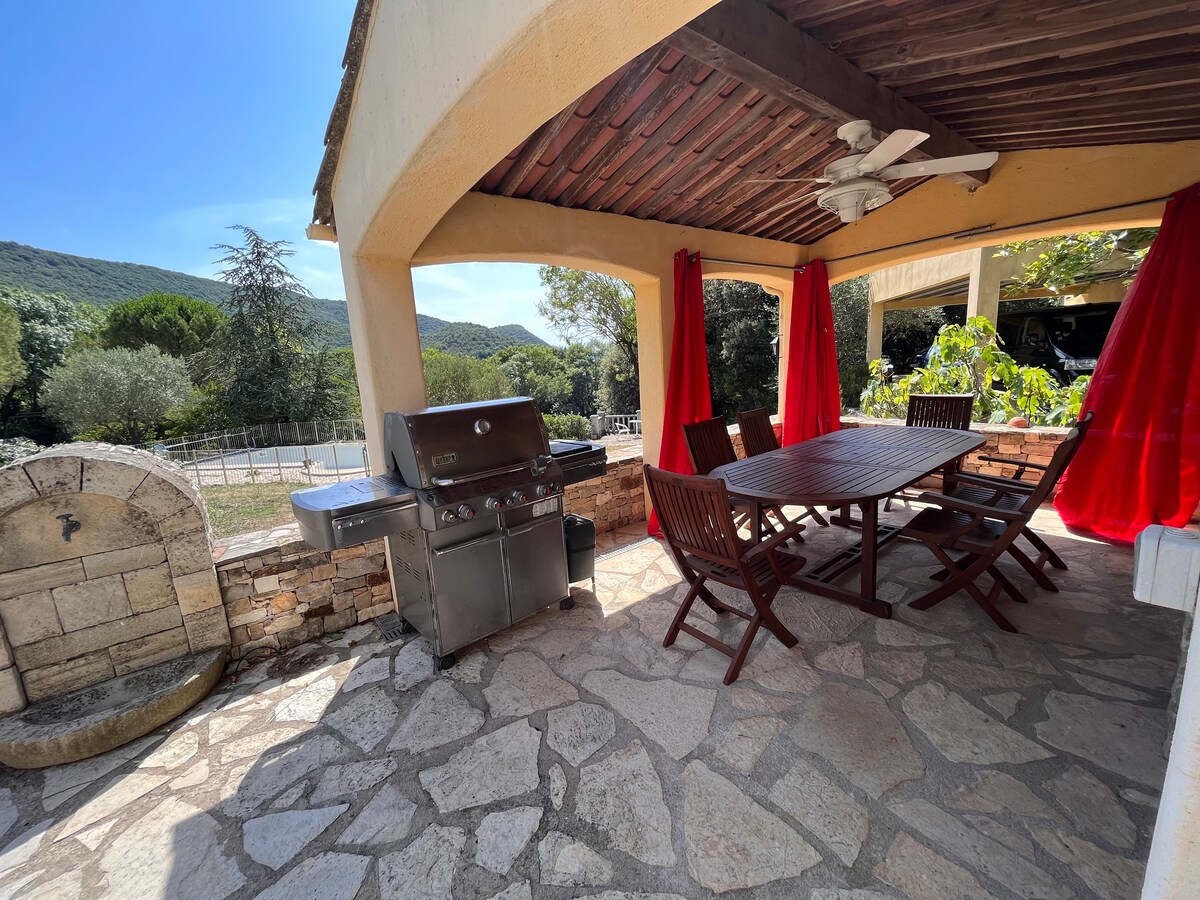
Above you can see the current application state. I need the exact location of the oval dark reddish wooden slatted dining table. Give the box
[709,426,985,618]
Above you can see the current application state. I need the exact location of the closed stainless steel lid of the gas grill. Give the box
[384,397,550,488]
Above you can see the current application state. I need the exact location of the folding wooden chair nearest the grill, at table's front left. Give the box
[643,466,805,684]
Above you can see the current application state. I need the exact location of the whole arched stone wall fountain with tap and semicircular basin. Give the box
[0,444,229,768]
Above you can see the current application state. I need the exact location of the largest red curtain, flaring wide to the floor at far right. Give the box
[1055,184,1200,541]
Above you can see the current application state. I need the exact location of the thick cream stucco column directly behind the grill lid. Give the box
[342,251,425,474]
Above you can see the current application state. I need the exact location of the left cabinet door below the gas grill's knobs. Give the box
[430,532,510,655]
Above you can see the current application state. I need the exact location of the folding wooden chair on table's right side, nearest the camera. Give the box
[901,420,1090,631]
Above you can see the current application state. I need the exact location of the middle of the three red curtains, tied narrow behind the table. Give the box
[784,259,841,446]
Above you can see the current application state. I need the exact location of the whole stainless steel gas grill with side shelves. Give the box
[292,397,607,667]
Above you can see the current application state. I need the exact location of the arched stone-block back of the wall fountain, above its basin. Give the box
[0,443,229,712]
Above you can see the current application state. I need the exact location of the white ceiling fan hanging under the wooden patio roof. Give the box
[749,119,1000,222]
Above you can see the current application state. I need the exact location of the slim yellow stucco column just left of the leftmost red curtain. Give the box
[634,273,674,466]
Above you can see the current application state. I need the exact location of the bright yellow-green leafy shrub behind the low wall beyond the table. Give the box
[862,316,1091,425]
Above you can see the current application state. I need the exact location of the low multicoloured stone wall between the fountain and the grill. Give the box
[217,526,395,659]
